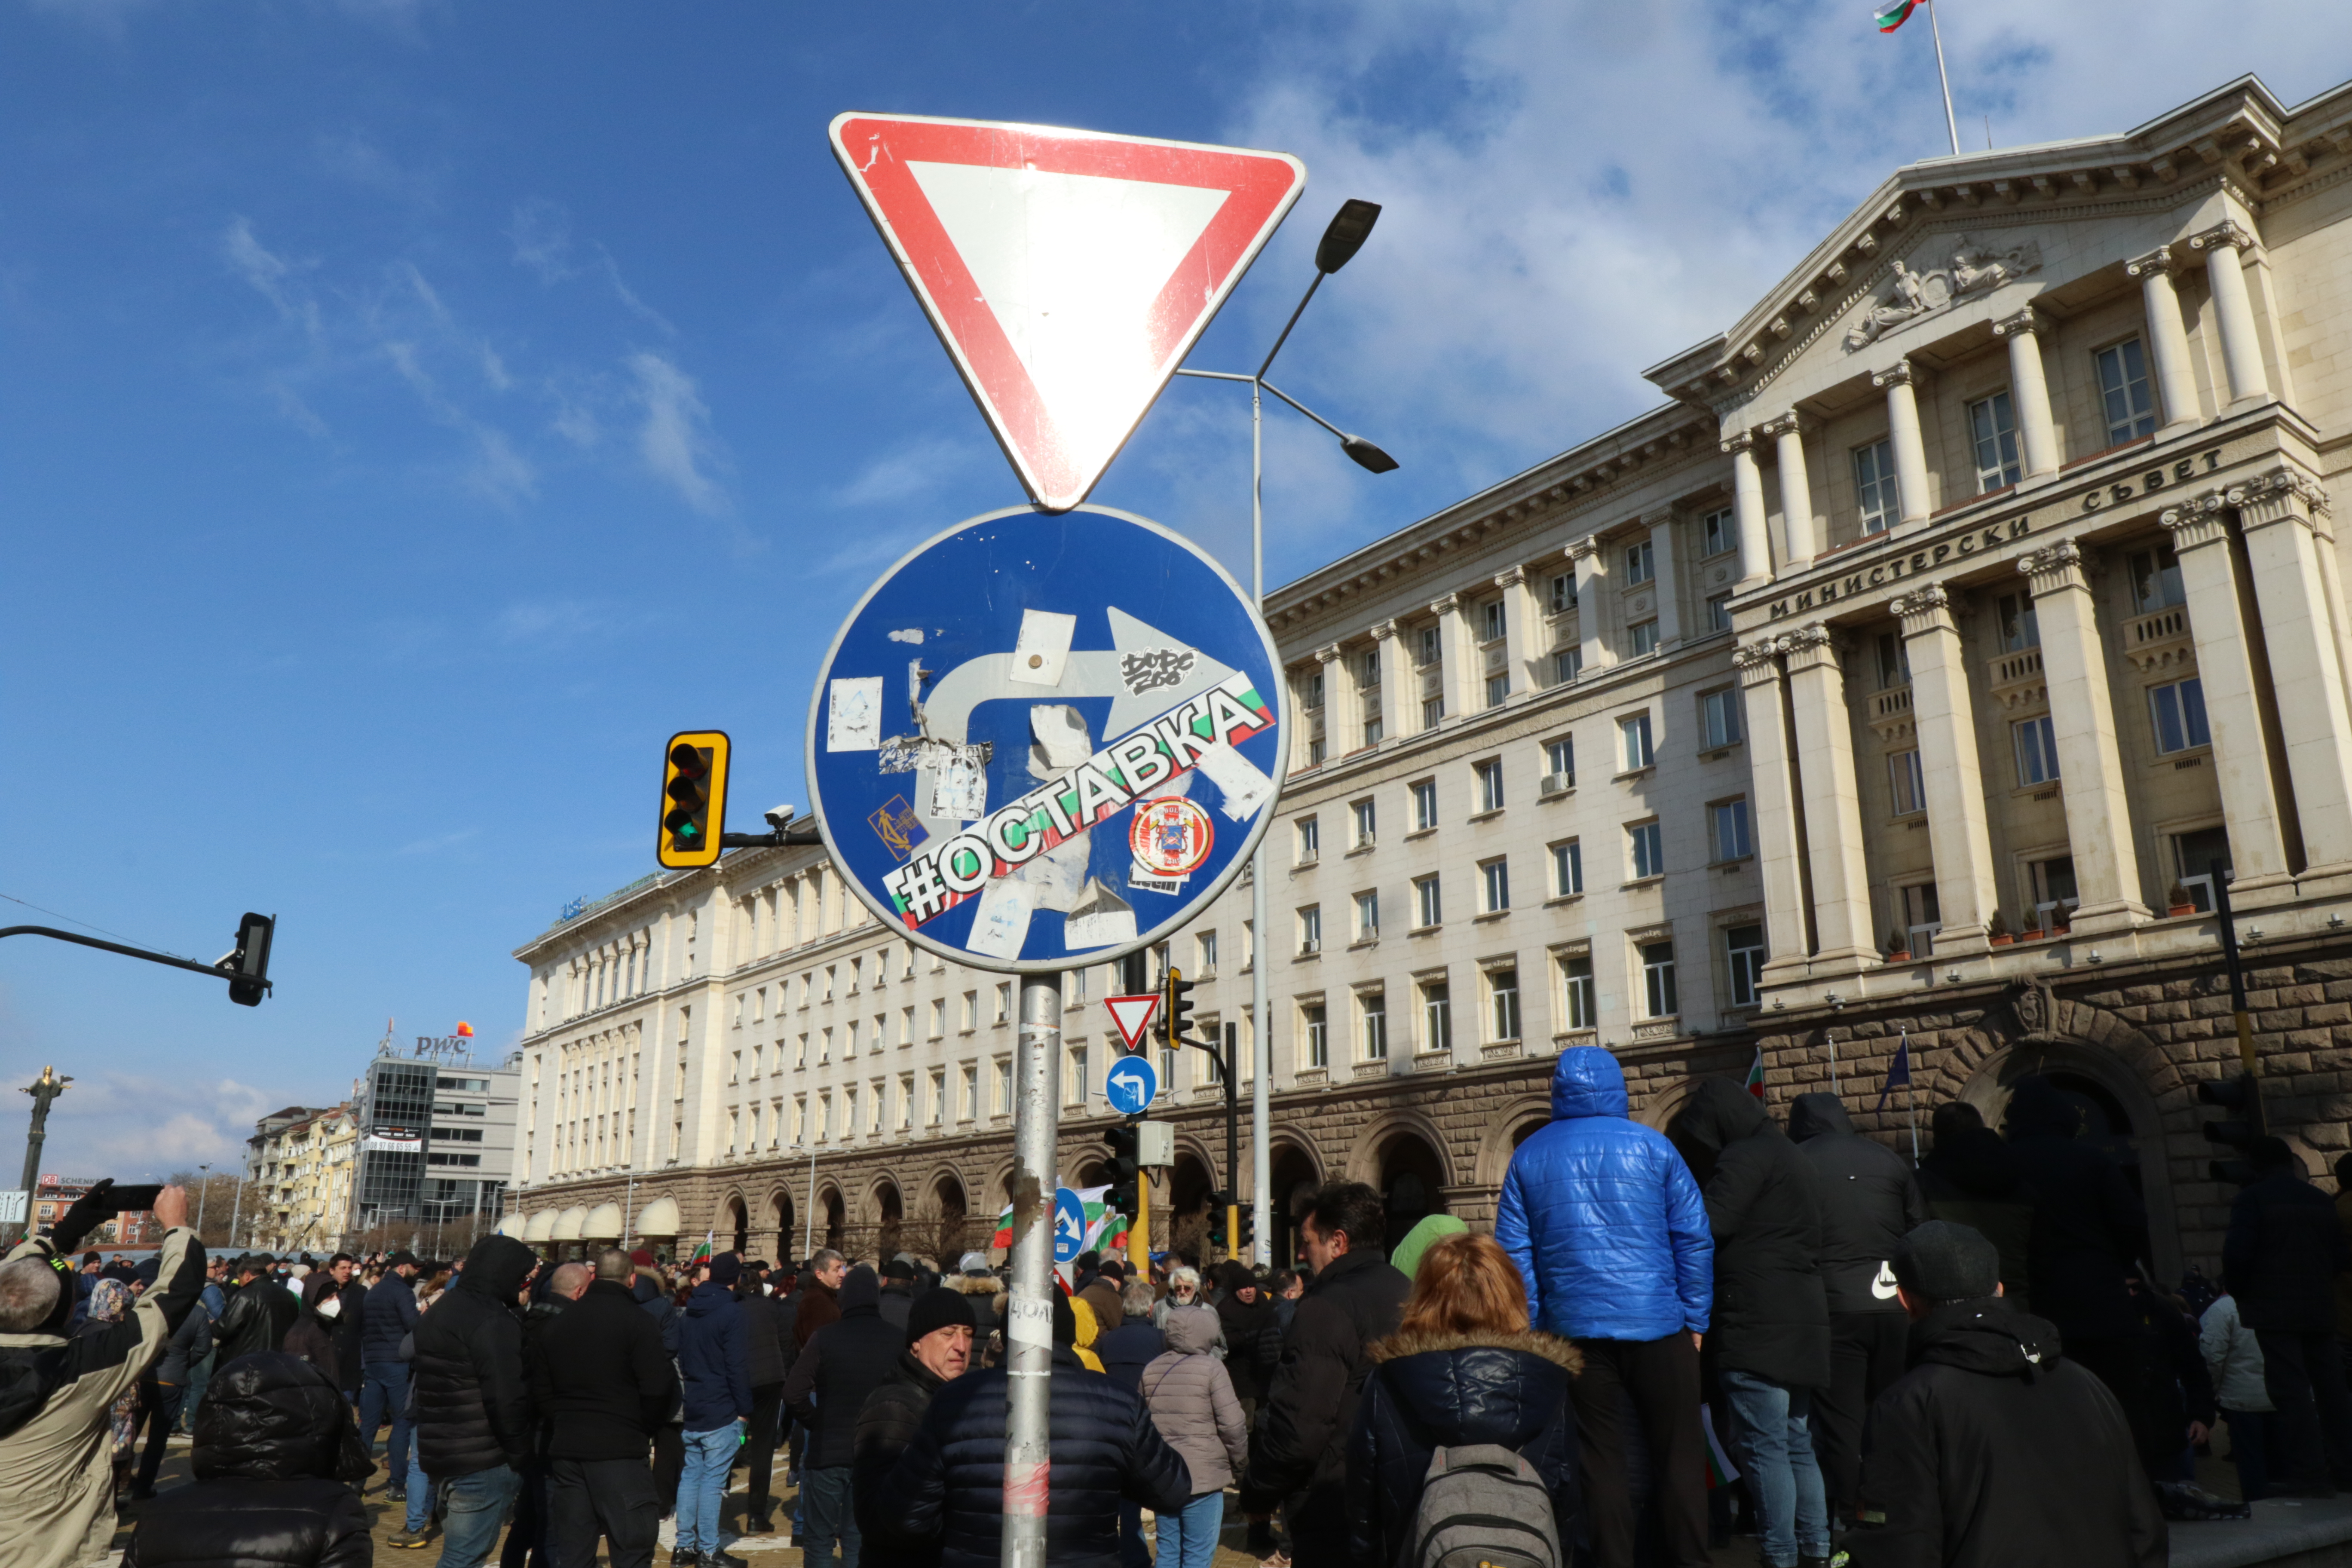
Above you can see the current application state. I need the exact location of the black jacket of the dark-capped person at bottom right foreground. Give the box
[1844,1295,2168,1568]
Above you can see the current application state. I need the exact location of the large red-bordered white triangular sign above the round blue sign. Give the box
[833,115,1308,512]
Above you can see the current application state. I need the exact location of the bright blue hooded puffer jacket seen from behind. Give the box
[1494,1046,1715,1340]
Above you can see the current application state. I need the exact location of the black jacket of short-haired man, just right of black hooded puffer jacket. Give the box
[529,1279,677,1474]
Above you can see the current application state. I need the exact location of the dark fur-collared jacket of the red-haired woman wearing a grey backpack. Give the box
[1348,1333,1583,1563]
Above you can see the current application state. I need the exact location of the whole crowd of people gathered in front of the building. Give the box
[0,1048,2352,1568]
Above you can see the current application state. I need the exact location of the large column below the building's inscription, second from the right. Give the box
[2162,503,2288,896]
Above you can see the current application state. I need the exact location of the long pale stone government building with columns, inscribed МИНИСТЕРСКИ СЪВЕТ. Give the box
[515,77,2352,1274]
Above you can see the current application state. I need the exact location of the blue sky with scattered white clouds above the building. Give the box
[0,0,2352,1176]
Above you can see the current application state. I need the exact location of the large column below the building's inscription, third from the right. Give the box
[2018,538,2150,936]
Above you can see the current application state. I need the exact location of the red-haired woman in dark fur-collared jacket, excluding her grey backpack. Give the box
[1348,1234,1583,1563]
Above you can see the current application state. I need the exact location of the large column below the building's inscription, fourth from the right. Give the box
[1891,583,1999,959]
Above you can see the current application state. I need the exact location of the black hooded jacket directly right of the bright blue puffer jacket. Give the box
[1675,1079,1830,1389]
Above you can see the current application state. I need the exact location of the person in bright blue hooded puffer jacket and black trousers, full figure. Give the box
[1494,1046,1715,1568]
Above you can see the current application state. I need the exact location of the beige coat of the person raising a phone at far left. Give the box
[0,1227,205,1568]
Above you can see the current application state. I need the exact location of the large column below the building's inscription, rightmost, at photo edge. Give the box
[2206,468,2352,875]
